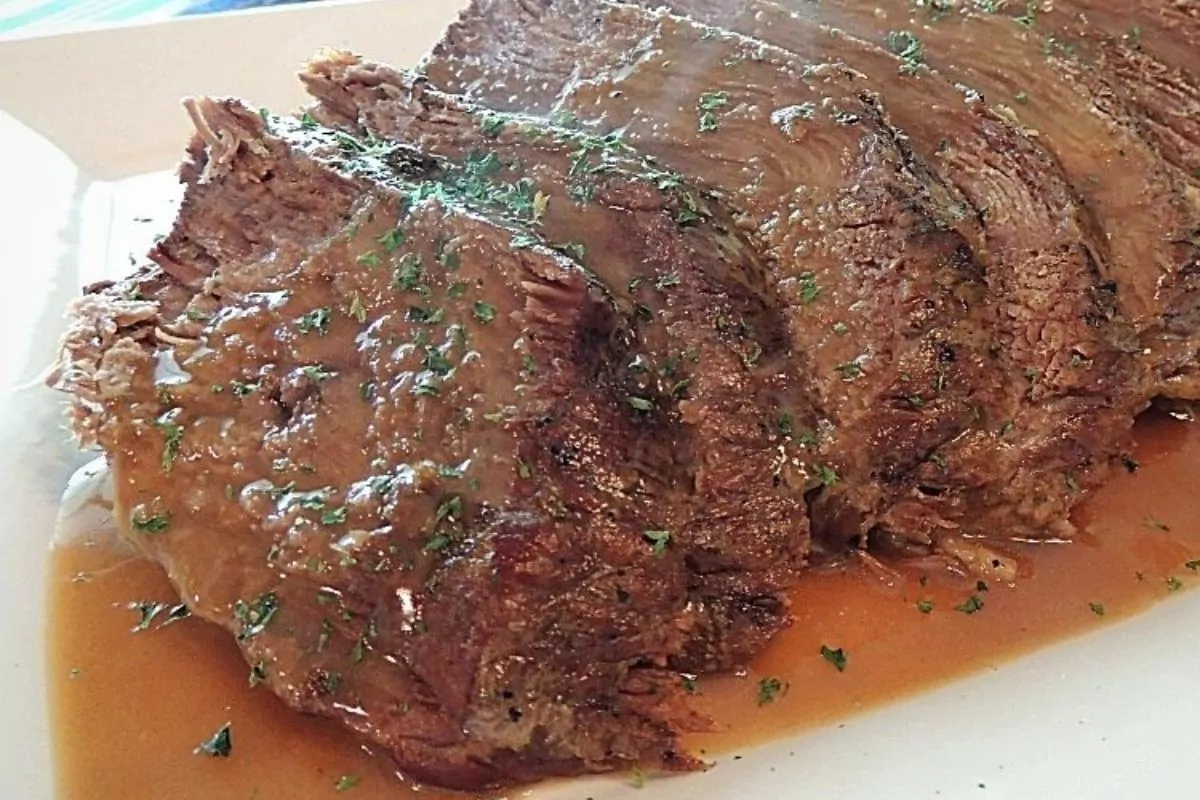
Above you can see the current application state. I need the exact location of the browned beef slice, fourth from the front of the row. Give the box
[619,0,1146,556]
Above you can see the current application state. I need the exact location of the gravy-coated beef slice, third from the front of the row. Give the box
[425,2,991,552]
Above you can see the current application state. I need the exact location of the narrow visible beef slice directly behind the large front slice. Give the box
[301,52,815,652]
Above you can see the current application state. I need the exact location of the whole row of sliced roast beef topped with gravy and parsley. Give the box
[52,0,1200,790]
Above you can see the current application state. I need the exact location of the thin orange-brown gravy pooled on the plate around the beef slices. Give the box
[49,416,1200,800]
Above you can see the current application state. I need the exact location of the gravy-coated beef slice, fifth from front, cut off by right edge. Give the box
[780,0,1200,399]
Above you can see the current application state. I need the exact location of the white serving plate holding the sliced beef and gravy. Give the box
[0,0,1200,800]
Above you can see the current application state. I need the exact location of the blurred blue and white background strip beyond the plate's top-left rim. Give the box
[0,0,312,37]
